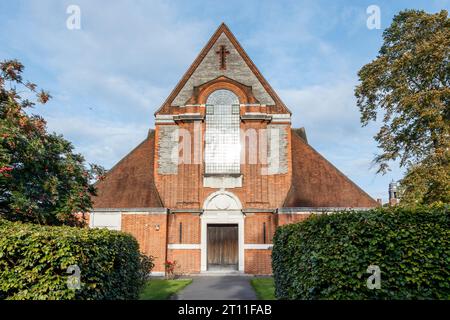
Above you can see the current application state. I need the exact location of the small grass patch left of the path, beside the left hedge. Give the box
[139,279,192,300]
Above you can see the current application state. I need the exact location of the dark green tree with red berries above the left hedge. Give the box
[0,60,104,225]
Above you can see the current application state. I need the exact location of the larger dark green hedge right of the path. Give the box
[272,206,450,299]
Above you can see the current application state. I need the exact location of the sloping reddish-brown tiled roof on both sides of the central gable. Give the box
[93,129,378,210]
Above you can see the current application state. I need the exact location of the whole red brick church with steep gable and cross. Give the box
[89,24,377,274]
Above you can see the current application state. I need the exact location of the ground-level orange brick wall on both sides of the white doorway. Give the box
[114,213,310,274]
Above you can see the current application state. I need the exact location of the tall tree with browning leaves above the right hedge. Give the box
[355,10,450,204]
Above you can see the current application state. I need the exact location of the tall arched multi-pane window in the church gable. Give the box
[205,89,241,174]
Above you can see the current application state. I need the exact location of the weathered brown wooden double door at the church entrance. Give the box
[207,224,239,270]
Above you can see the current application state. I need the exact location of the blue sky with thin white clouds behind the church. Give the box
[0,0,450,201]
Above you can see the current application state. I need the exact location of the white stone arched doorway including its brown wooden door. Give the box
[201,190,244,272]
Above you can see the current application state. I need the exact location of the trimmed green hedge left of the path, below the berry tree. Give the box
[0,219,153,300]
